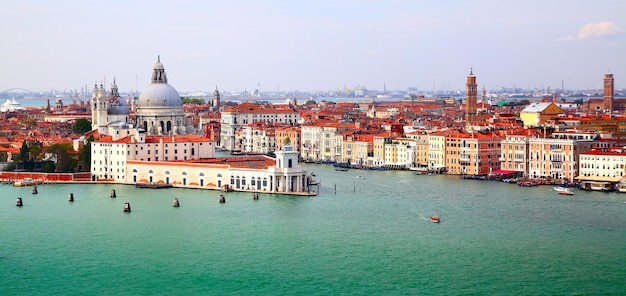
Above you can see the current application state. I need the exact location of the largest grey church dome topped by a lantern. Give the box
[137,57,183,108]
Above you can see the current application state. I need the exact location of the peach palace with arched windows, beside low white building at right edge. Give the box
[528,137,594,182]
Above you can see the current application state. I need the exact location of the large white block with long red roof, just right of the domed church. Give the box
[220,102,300,151]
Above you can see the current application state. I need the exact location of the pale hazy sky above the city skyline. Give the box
[0,0,626,93]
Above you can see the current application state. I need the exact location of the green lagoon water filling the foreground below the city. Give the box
[0,165,626,295]
